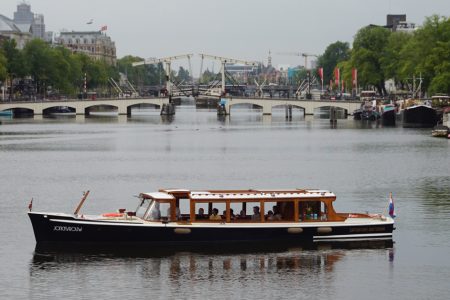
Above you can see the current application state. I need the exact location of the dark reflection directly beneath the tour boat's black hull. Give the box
[31,240,393,273]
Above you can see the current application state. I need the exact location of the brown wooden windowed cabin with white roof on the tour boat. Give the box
[140,189,346,223]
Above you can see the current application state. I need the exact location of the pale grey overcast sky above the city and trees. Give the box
[0,0,450,73]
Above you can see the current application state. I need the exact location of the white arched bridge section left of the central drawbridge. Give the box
[0,98,169,115]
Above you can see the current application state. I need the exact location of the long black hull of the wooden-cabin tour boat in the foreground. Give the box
[29,213,394,244]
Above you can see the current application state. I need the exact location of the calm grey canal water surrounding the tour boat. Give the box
[0,107,450,299]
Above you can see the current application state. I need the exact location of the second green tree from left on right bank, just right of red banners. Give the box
[351,26,391,94]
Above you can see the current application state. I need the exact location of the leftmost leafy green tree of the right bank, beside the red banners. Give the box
[317,41,350,83]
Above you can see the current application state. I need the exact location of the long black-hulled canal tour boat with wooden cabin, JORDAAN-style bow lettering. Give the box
[28,189,394,245]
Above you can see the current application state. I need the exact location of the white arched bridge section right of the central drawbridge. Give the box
[223,97,361,115]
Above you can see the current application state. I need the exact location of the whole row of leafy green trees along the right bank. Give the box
[318,15,450,94]
